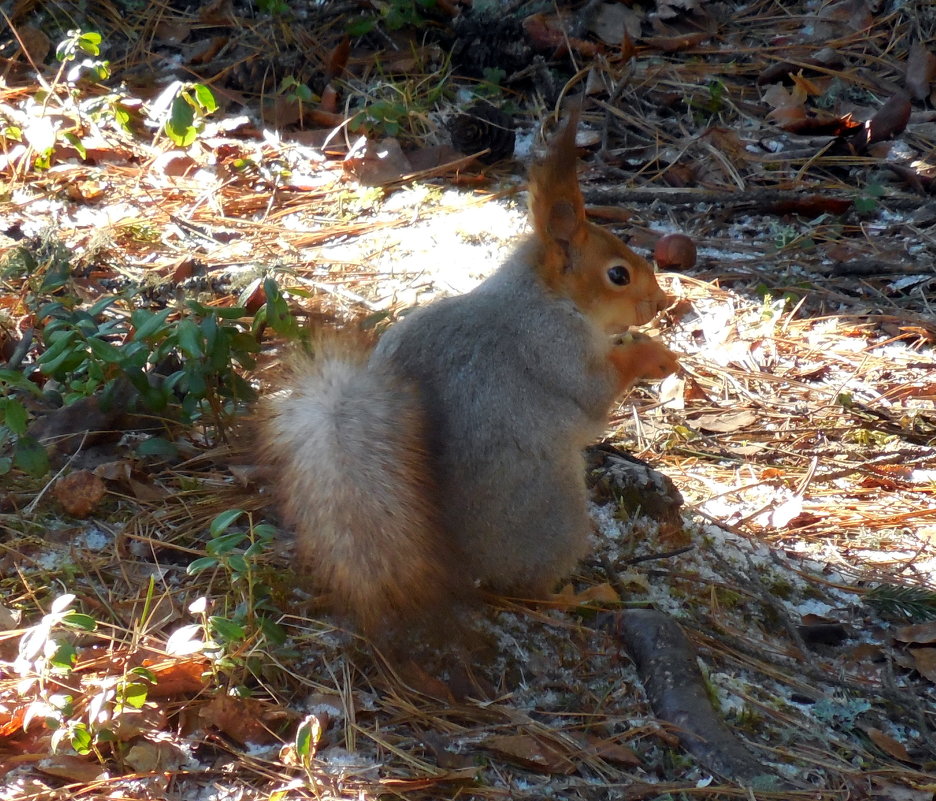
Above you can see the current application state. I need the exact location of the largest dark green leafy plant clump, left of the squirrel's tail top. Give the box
[0,266,310,476]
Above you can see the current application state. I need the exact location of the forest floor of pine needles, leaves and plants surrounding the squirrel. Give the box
[0,0,936,801]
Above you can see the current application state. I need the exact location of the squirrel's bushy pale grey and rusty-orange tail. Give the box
[260,343,457,637]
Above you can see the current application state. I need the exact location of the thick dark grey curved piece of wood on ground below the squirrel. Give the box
[616,609,785,789]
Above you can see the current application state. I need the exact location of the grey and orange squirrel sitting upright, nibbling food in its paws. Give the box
[259,114,677,637]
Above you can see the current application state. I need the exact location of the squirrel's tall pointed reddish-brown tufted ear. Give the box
[529,107,585,255]
